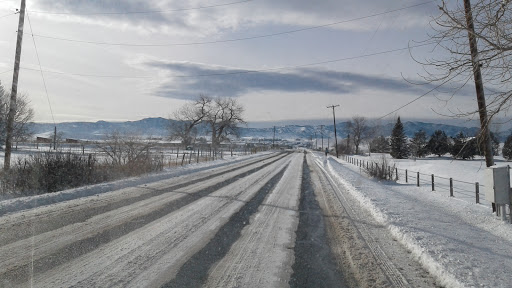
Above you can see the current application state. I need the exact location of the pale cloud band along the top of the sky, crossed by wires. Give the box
[29,0,437,36]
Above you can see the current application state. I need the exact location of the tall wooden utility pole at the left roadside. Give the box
[4,0,25,171]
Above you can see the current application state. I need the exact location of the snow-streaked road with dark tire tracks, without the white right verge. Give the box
[0,153,435,287]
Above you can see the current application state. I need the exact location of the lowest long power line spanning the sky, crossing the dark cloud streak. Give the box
[22,43,436,79]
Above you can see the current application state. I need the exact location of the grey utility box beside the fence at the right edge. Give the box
[485,166,510,204]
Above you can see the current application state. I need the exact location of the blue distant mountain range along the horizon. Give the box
[33,118,492,140]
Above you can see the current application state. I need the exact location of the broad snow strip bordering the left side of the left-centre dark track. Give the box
[35,152,289,288]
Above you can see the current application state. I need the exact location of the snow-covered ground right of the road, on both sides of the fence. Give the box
[317,154,512,287]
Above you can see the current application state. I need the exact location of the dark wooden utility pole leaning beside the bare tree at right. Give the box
[464,0,494,167]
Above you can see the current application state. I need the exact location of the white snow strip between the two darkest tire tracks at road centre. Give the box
[204,154,303,287]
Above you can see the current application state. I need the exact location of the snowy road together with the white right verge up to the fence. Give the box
[0,151,512,287]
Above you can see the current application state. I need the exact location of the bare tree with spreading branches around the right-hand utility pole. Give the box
[419,0,512,166]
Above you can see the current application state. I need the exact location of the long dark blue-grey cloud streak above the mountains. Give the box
[143,60,431,99]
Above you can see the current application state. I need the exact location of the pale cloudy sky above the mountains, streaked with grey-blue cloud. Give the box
[0,0,476,122]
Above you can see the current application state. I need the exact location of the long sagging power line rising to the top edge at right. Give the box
[30,1,435,47]
